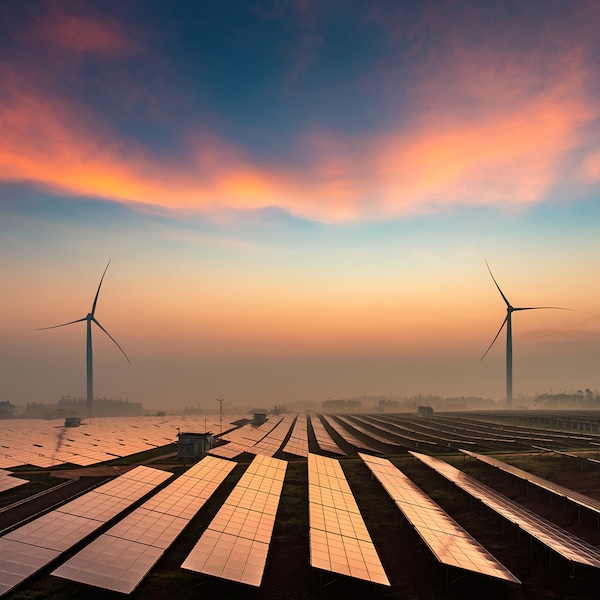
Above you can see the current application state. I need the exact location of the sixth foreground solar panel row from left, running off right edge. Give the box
[411,452,600,568]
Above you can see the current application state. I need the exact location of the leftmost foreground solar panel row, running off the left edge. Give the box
[0,467,172,595]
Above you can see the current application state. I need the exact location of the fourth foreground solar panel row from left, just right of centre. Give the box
[308,453,390,585]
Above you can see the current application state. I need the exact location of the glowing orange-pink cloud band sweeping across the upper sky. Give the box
[0,0,599,222]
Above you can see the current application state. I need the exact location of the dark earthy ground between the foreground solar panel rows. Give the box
[0,412,600,600]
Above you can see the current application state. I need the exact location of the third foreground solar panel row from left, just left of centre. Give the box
[181,455,287,587]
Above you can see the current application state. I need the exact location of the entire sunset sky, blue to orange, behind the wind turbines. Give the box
[0,0,600,408]
